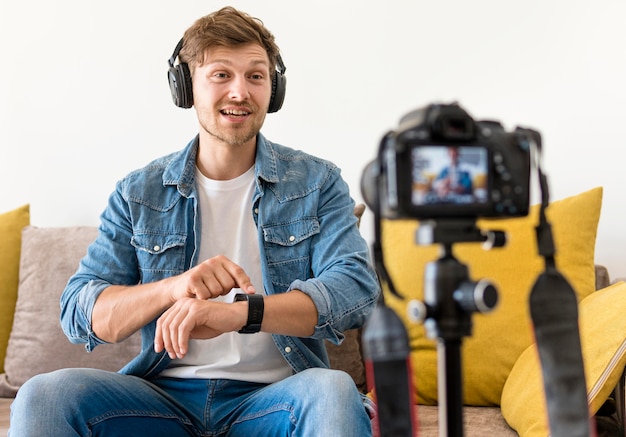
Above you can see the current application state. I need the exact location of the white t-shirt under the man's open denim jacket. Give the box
[162,167,293,383]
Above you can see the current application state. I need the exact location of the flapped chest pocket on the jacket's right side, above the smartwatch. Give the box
[263,218,320,291]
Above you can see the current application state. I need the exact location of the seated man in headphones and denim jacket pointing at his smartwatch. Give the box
[10,7,379,437]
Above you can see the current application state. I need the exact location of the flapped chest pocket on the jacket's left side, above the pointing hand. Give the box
[131,232,187,278]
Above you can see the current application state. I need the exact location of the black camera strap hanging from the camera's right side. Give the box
[518,128,595,437]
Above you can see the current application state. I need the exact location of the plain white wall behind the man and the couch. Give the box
[0,0,626,276]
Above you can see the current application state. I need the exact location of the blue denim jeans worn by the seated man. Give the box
[9,369,372,437]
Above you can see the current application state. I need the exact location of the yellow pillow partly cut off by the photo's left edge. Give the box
[0,205,30,373]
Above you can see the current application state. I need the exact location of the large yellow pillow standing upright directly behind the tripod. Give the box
[382,187,602,406]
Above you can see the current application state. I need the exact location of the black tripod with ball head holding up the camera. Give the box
[413,219,504,437]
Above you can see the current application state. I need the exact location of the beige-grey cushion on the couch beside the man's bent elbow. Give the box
[0,226,140,397]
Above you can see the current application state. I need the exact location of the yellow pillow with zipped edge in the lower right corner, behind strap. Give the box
[501,282,626,437]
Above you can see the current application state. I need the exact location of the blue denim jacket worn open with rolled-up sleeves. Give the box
[61,134,380,378]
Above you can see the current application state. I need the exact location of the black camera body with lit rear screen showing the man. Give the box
[362,103,531,219]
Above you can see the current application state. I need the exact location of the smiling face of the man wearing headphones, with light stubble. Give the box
[192,44,272,145]
